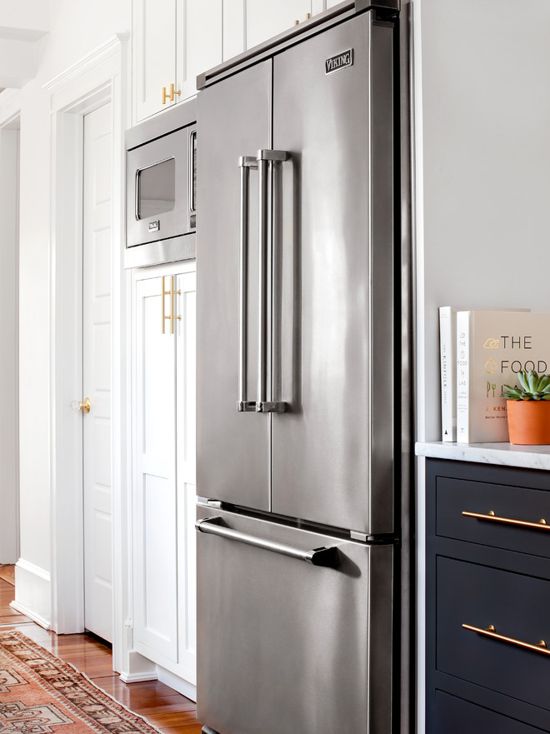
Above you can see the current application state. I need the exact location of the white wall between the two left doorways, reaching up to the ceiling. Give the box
[0,0,131,623]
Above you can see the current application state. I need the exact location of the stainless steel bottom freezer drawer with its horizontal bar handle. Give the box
[197,506,393,734]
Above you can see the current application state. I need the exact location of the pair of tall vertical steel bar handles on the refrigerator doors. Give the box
[237,150,289,413]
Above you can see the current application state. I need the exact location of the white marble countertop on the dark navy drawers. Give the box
[416,441,550,471]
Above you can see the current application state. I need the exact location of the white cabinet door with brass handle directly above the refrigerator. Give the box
[245,0,313,48]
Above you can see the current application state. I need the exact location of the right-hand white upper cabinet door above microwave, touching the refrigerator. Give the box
[177,0,223,101]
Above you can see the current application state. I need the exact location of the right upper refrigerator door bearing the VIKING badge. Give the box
[272,12,395,536]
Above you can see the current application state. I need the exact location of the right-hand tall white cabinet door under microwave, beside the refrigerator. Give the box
[176,272,197,685]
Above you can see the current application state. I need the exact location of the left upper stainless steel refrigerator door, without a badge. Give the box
[197,60,272,510]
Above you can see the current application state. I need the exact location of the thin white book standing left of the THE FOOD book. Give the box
[439,306,464,441]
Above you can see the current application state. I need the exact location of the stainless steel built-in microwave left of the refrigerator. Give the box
[125,100,197,268]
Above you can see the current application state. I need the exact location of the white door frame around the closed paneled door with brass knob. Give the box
[45,35,129,670]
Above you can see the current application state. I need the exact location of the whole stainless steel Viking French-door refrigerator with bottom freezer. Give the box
[197,0,410,734]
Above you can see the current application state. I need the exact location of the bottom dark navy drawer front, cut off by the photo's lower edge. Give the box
[436,691,544,734]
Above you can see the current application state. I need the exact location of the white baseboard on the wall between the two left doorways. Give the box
[11,558,51,629]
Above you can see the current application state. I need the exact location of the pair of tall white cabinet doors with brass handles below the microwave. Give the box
[132,262,196,695]
